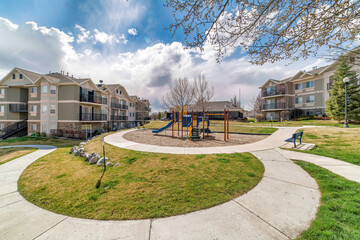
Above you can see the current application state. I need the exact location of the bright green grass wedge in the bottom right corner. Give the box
[296,161,360,240]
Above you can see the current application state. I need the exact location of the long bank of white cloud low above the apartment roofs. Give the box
[0,19,323,110]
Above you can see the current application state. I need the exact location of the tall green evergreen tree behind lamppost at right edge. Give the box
[325,61,360,121]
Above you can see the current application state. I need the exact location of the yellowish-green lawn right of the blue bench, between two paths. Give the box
[303,127,360,165]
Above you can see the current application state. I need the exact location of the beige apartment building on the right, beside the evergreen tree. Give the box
[260,54,360,120]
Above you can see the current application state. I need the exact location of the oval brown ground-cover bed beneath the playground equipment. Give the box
[123,130,267,147]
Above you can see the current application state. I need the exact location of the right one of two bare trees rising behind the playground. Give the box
[194,75,215,110]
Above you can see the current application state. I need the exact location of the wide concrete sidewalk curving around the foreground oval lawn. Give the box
[0,143,320,240]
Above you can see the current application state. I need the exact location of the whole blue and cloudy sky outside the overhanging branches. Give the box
[0,0,328,111]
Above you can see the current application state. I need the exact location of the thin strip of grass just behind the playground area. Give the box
[144,120,277,134]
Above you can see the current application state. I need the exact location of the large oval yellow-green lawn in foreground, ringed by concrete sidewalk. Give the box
[18,133,264,220]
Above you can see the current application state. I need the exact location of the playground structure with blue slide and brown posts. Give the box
[152,108,229,141]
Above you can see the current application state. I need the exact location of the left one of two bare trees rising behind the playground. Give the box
[162,78,194,110]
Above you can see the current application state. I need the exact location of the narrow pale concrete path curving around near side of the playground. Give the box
[105,127,304,154]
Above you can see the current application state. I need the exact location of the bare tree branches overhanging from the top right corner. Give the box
[164,0,360,64]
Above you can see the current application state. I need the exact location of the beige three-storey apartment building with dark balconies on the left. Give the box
[0,68,150,138]
